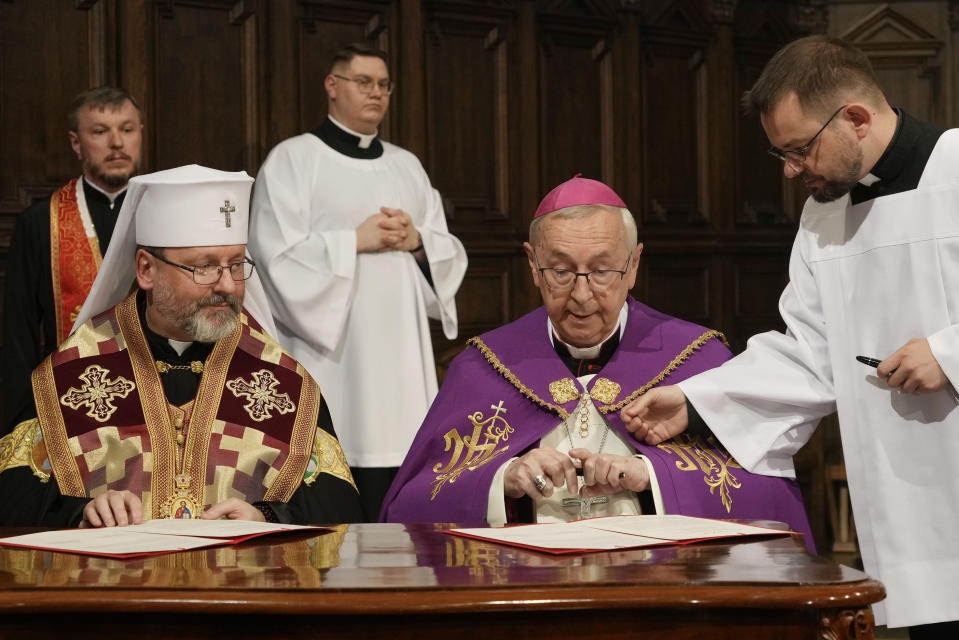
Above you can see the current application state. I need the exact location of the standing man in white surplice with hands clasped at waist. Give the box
[250,45,466,520]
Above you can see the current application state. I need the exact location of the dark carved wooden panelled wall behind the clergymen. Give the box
[0,0,959,552]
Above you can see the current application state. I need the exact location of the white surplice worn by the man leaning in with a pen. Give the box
[679,129,959,627]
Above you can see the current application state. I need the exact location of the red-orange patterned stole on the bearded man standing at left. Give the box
[50,178,103,344]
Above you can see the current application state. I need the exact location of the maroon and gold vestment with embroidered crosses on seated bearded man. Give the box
[33,294,320,518]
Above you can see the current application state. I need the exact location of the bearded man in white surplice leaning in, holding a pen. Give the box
[623,36,959,640]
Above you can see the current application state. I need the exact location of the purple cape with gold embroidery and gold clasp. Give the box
[381,298,812,543]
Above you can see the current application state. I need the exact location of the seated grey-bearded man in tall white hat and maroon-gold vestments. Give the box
[0,165,362,527]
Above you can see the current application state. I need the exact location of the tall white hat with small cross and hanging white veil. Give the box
[73,164,276,335]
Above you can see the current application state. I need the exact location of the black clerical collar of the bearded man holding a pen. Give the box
[849,108,942,204]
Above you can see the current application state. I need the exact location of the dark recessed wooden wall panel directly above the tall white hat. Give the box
[152,3,249,171]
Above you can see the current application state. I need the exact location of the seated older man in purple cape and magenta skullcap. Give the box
[381,177,812,547]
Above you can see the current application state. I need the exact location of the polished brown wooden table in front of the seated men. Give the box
[0,524,884,640]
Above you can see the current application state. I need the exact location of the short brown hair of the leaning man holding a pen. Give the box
[742,35,885,115]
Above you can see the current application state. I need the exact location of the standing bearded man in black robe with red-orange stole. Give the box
[0,86,143,435]
